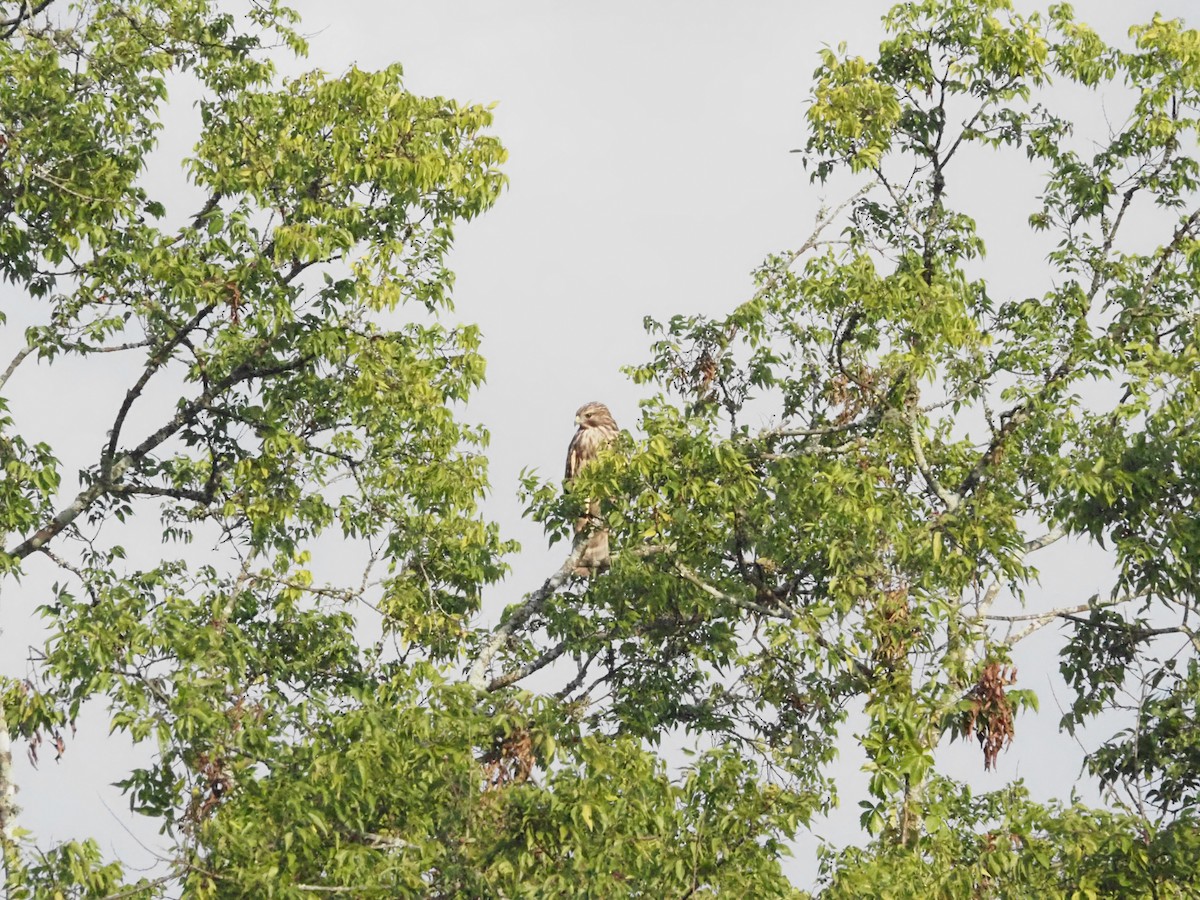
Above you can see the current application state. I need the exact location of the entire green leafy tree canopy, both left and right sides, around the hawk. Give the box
[0,0,1200,898]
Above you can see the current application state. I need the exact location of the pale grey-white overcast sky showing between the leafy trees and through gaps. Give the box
[0,0,1192,881]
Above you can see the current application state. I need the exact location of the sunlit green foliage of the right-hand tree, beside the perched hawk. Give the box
[520,0,1200,898]
